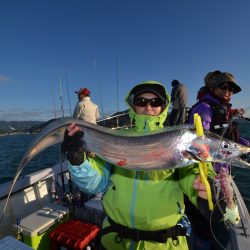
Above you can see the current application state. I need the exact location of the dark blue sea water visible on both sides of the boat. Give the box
[0,122,250,211]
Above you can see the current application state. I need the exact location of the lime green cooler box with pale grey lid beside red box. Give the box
[20,204,69,250]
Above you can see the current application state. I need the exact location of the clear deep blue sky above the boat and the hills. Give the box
[0,0,250,121]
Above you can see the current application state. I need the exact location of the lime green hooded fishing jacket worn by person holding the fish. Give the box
[69,81,215,250]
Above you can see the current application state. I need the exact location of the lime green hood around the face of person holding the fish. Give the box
[125,80,170,132]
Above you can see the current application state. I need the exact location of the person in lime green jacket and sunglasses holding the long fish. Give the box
[62,81,218,250]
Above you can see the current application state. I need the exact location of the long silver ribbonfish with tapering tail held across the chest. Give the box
[3,118,250,222]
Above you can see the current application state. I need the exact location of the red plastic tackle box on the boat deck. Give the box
[49,220,100,250]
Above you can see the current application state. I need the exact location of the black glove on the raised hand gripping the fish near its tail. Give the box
[61,129,85,166]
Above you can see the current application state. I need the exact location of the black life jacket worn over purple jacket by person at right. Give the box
[190,100,239,142]
